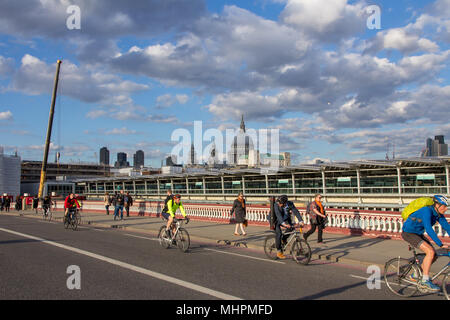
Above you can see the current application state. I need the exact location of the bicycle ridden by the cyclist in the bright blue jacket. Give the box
[384,246,450,300]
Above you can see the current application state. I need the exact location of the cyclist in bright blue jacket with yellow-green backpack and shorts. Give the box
[402,195,450,292]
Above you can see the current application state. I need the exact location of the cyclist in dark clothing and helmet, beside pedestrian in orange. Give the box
[274,195,303,259]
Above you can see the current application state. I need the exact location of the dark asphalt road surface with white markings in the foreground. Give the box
[0,215,444,300]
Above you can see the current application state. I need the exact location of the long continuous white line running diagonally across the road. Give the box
[0,228,242,300]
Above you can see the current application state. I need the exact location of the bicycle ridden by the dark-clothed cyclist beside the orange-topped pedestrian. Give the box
[264,228,311,265]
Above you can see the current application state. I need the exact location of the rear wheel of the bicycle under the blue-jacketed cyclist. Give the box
[384,258,422,297]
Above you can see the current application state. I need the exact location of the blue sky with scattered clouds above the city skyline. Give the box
[0,0,450,167]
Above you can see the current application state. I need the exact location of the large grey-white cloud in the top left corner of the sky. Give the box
[0,0,206,63]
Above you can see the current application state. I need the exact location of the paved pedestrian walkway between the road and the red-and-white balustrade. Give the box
[4,211,447,270]
